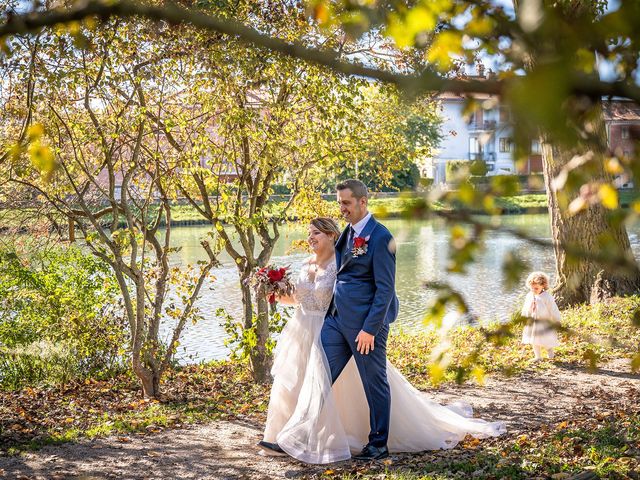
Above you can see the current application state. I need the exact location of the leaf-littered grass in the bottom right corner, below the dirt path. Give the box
[319,412,640,480]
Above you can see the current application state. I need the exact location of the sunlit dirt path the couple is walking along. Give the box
[0,361,640,480]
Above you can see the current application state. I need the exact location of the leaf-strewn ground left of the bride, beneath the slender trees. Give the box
[0,361,270,454]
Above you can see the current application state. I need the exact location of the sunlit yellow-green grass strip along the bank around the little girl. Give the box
[388,296,640,389]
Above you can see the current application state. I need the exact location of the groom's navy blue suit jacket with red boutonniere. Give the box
[329,217,399,335]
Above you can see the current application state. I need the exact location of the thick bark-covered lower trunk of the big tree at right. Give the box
[543,138,640,308]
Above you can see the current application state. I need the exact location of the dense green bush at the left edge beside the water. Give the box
[0,242,127,388]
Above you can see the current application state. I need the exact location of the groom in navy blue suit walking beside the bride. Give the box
[321,180,398,460]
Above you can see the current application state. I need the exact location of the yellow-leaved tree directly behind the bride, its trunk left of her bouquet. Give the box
[139,2,437,381]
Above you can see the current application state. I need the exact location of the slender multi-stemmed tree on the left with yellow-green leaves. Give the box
[3,21,217,397]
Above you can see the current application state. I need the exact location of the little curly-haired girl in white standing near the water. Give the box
[521,272,560,360]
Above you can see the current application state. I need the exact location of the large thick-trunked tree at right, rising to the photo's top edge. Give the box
[511,0,640,307]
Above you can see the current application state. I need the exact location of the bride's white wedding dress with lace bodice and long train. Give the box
[264,262,506,463]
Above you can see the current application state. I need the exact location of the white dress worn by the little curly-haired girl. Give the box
[521,290,560,348]
